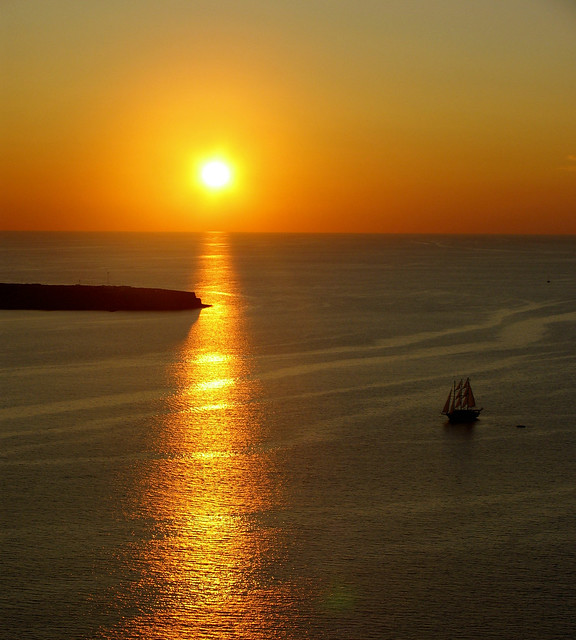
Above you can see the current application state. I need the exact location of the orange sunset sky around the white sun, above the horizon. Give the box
[0,0,576,234]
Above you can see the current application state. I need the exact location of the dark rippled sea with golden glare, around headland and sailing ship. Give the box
[0,232,576,640]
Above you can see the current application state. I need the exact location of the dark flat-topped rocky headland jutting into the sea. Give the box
[0,283,210,311]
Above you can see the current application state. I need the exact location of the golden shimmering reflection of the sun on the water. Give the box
[125,236,288,640]
